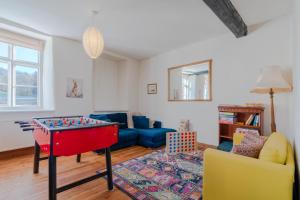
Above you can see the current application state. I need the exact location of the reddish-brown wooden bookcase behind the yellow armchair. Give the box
[218,105,264,143]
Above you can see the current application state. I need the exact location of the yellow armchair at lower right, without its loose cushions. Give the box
[203,144,295,200]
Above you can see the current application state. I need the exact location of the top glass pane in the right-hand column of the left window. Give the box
[14,46,39,63]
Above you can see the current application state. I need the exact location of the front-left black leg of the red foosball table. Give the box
[49,155,57,200]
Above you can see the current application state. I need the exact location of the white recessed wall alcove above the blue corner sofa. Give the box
[93,57,139,112]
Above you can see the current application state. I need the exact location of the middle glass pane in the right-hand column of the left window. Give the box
[16,65,38,86]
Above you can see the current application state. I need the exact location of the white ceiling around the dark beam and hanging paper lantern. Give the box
[0,0,291,59]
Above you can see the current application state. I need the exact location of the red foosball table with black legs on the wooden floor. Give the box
[16,116,118,200]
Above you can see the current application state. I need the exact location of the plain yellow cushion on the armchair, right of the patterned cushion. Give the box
[259,133,288,164]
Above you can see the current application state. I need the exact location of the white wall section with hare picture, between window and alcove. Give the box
[53,37,93,115]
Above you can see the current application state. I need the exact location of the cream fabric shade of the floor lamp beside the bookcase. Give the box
[251,66,291,93]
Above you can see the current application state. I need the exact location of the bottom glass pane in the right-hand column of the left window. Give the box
[16,86,38,106]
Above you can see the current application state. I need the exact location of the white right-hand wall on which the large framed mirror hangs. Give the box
[139,16,292,144]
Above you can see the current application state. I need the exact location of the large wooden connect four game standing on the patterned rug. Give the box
[166,132,197,155]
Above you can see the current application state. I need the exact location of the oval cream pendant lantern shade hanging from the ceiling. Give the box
[82,27,104,59]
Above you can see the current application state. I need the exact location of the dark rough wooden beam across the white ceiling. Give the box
[203,0,248,38]
